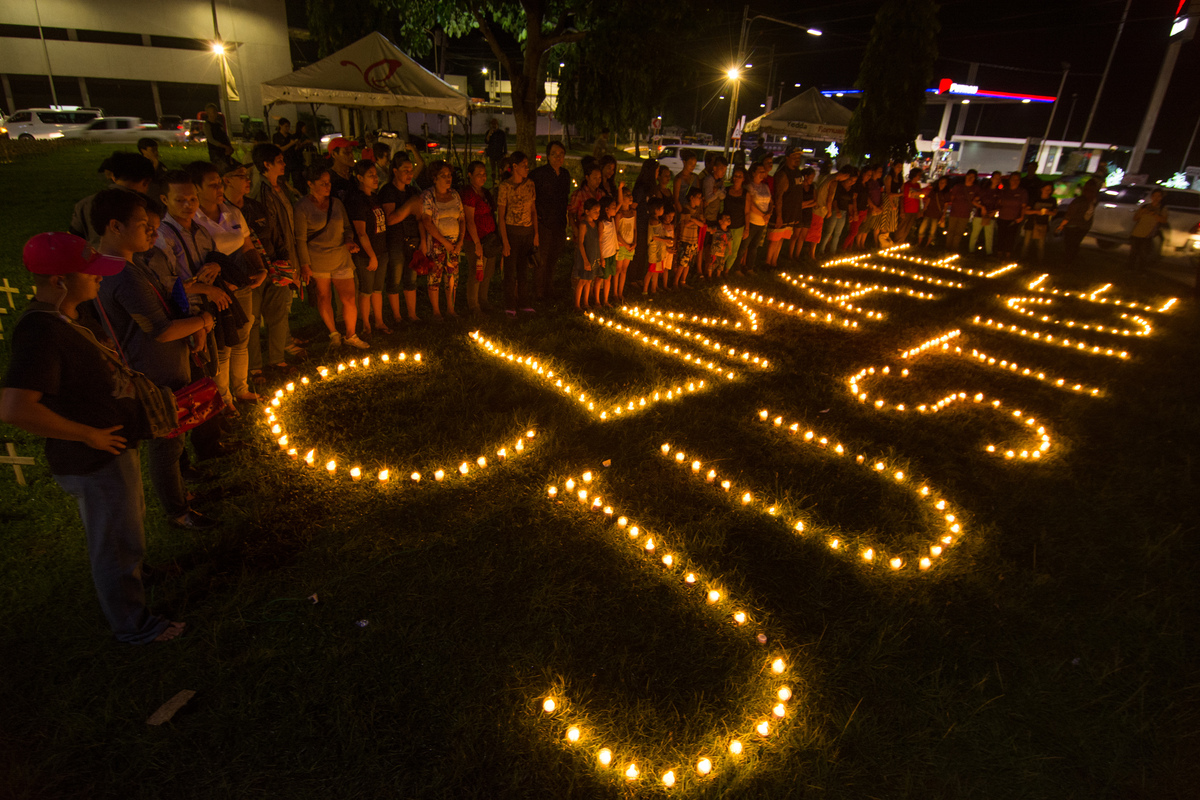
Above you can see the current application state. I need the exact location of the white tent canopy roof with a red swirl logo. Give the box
[263,32,469,116]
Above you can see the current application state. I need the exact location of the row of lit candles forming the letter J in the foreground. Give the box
[539,471,793,788]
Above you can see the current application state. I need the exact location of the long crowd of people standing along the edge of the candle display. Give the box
[0,122,1132,643]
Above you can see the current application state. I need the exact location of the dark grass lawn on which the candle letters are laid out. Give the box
[0,148,1200,800]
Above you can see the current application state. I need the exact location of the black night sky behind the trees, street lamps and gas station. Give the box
[289,0,1200,179]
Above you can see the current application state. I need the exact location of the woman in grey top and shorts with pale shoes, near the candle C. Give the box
[295,164,368,350]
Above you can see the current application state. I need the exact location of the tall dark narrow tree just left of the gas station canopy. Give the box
[846,0,940,158]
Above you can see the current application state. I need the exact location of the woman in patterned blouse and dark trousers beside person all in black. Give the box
[496,150,538,317]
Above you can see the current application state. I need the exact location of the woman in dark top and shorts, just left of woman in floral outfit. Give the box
[379,156,425,323]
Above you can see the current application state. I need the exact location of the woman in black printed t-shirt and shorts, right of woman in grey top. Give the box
[346,160,391,336]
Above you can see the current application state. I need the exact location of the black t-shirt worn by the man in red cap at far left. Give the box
[0,299,142,475]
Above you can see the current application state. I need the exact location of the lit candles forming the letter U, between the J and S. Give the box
[659,438,962,572]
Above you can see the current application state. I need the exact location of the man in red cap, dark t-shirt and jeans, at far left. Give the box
[0,230,184,644]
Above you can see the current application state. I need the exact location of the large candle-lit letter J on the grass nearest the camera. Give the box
[533,471,796,790]
